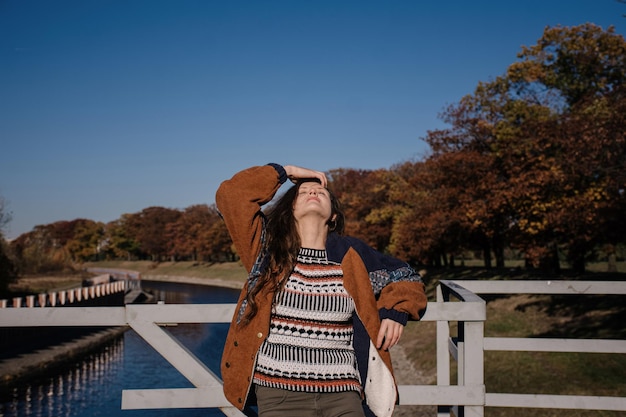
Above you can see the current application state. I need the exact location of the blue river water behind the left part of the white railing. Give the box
[0,281,239,417]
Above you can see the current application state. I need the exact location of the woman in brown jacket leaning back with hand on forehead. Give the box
[216,164,426,417]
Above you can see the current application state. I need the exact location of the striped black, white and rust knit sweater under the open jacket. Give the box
[254,249,361,392]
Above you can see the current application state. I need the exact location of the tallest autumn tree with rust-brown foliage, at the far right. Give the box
[426,24,626,271]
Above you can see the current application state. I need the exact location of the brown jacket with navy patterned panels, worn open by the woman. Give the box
[216,164,427,416]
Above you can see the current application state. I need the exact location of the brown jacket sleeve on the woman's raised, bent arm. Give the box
[215,164,287,272]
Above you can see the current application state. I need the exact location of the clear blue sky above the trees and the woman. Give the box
[0,0,626,238]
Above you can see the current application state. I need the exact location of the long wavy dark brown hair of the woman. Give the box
[243,178,345,324]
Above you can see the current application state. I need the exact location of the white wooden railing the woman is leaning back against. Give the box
[0,281,626,416]
